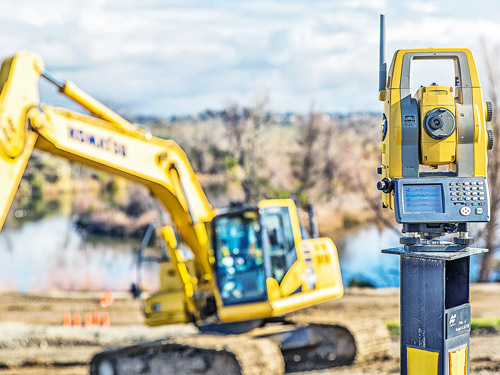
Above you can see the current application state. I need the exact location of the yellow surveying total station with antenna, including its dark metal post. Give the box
[377,15,493,375]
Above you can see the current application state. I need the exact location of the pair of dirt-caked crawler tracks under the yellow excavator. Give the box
[90,310,390,375]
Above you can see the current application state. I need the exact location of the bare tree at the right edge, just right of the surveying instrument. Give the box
[479,40,500,282]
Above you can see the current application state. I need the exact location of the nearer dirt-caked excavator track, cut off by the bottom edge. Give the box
[90,334,285,375]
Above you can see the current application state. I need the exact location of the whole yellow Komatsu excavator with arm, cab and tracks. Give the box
[0,52,387,375]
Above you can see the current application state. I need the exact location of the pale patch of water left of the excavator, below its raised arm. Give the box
[0,216,137,291]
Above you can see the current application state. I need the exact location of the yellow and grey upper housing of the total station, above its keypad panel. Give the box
[378,44,493,209]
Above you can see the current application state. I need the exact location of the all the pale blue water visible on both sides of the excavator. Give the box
[0,214,492,291]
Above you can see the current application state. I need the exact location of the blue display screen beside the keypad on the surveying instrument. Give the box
[403,184,444,213]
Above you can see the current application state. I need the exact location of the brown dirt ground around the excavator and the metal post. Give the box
[0,284,500,375]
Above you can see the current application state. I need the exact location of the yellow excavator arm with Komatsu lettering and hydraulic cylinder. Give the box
[0,52,214,324]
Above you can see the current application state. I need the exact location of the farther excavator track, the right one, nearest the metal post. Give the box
[282,311,390,372]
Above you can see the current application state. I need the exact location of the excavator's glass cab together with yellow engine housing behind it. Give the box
[211,199,343,322]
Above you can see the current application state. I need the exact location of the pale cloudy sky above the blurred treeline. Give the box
[0,0,500,116]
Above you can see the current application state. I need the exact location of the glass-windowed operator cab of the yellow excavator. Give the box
[212,200,302,306]
